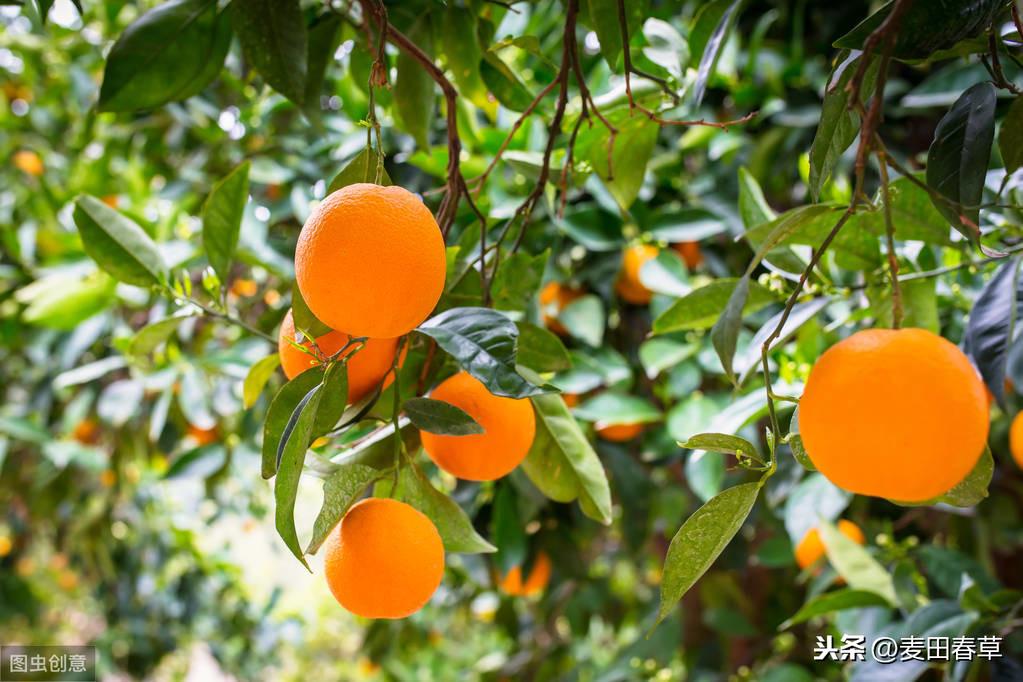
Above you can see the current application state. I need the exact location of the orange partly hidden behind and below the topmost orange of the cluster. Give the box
[277,311,404,404]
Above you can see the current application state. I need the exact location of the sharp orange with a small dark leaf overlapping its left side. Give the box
[421,372,536,481]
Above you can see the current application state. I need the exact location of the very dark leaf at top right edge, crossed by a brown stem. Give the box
[835,0,1006,60]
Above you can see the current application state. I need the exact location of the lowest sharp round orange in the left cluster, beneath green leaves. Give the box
[323,497,444,619]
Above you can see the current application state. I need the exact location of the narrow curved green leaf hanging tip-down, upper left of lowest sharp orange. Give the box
[273,384,322,573]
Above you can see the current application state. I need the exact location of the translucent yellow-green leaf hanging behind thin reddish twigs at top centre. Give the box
[589,116,660,211]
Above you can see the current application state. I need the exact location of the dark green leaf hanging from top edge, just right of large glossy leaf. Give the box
[230,0,309,106]
